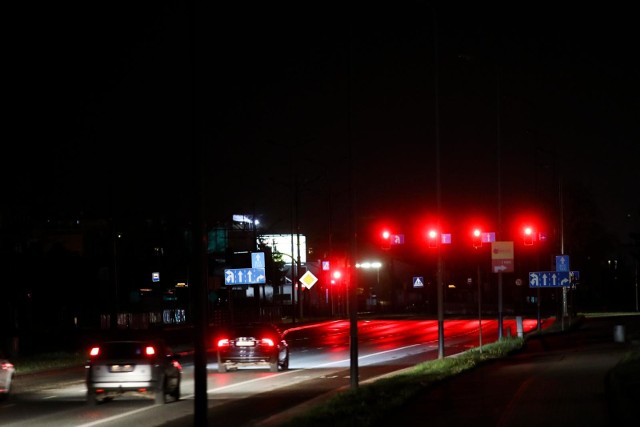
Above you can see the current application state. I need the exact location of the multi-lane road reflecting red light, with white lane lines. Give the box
[0,319,536,427]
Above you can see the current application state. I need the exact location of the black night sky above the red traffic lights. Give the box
[3,1,640,247]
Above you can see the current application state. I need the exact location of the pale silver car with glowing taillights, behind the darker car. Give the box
[86,340,182,405]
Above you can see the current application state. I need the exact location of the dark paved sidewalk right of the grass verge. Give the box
[378,315,640,427]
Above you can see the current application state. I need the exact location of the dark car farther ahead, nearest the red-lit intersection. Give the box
[214,323,289,373]
